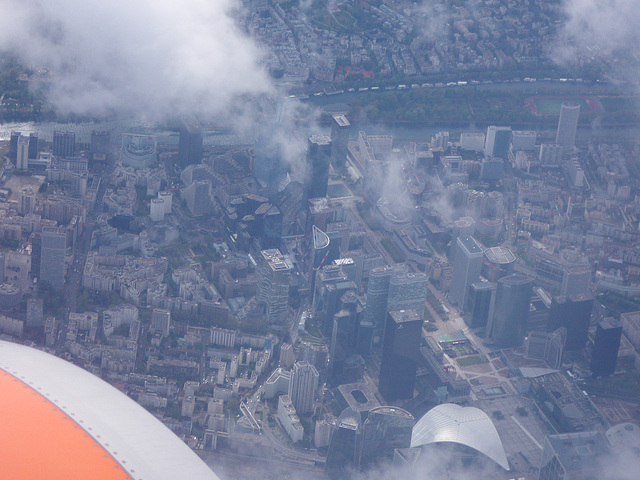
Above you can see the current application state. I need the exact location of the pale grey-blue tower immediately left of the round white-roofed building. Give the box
[450,237,483,308]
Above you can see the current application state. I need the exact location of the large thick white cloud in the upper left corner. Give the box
[0,0,272,118]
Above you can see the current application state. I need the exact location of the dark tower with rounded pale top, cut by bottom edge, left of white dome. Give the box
[324,407,362,480]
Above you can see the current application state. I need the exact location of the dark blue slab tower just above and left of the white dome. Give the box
[378,310,422,401]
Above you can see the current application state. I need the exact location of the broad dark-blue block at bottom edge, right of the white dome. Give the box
[538,432,611,480]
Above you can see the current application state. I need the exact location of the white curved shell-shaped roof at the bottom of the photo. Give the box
[411,403,509,470]
